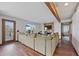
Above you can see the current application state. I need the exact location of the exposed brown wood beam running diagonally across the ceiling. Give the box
[45,2,60,22]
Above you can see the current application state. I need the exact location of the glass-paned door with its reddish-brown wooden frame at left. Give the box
[2,19,16,44]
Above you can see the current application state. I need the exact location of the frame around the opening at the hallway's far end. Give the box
[61,21,72,43]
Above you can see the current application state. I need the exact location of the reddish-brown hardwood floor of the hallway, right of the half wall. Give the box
[54,41,77,56]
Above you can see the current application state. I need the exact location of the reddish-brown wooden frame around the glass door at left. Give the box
[2,19,16,44]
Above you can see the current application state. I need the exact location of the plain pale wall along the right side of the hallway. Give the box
[72,7,79,55]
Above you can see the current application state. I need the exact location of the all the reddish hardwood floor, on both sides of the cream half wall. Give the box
[0,39,77,56]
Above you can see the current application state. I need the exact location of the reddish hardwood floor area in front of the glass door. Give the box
[0,42,42,56]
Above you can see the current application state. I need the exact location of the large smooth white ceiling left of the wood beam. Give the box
[0,2,55,23]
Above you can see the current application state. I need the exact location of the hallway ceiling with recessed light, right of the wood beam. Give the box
[55,2,78,20]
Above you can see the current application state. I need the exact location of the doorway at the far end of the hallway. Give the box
[61,22,72,43]
